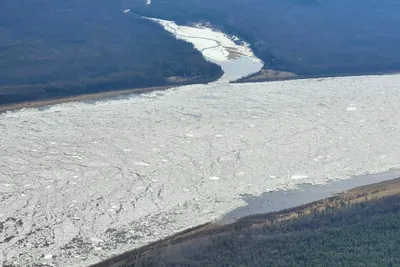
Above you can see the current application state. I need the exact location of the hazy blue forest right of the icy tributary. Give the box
[132,0,400,77]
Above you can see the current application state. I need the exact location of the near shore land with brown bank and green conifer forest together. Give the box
[92,178,400,267]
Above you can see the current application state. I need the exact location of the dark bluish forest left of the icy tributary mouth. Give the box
[0,0,222,105]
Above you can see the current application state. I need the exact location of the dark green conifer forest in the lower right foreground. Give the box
[124,195,400,267]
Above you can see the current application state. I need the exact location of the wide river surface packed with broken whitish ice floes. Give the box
[0,75,400,266]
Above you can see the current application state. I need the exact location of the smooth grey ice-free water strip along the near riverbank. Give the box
[223,170,400,221]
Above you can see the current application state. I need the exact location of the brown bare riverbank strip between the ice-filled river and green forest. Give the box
[91,174,400,267]
